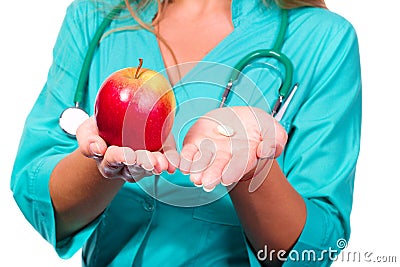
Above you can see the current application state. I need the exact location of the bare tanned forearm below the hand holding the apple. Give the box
[49,150,124,240]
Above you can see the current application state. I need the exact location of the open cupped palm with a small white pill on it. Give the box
[179,106,287,191]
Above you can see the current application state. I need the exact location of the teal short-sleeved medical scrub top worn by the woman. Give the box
[11,0,361,266]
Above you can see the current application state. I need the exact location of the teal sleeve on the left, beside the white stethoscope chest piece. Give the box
[11,1,102,258]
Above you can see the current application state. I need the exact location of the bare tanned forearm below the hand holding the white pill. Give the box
[230,160,306,264]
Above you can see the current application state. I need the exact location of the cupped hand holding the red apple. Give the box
[76,117,179,182]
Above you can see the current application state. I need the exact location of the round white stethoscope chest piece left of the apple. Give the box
[59,107,89,137]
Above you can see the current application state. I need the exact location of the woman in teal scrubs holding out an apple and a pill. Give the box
[11,0,361,266]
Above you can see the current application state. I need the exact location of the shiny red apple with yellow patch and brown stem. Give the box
[94,59,176,151]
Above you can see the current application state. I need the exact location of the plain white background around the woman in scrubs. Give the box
[0,0,400,266]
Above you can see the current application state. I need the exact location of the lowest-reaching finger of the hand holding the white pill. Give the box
[202,151,232,191]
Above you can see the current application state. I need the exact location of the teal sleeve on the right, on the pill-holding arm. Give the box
[248,18,361,266]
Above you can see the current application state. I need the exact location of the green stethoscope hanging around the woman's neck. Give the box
[59,4,298,136]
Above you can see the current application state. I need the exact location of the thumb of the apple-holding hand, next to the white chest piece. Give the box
[76,116,107,158]
